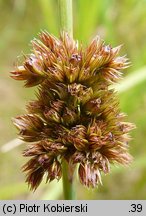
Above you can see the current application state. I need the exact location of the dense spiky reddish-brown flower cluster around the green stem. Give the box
[11,32,134,190]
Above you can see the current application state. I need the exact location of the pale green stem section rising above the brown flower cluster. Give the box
[59,0,73,37]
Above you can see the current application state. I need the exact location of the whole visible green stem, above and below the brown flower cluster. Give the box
[59,0,75,200]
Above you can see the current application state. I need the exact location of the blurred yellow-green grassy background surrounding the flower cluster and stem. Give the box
[0,0,146,199]
